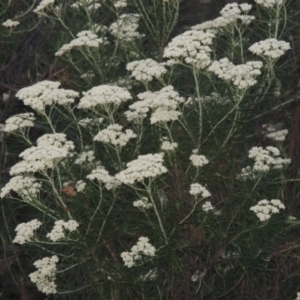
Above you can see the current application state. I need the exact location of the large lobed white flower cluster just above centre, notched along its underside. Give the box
[124,85,184,124]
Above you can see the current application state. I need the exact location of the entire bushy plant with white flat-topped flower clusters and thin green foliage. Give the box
[0,0,300,300]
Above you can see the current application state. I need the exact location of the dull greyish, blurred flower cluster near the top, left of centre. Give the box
[109,14,143,42]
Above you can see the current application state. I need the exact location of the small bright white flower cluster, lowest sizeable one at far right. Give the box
[250,199,285,222]
